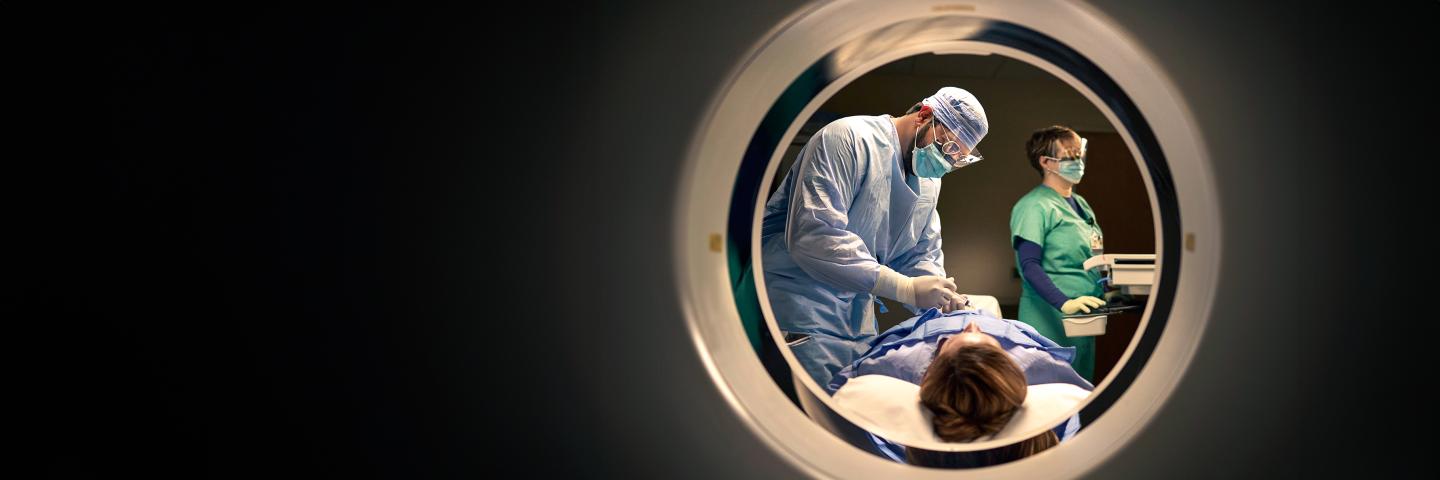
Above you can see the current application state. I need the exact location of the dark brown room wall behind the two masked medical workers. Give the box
[776,61,1153,329]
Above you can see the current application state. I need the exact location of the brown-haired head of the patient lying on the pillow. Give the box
[920,321,1025,441]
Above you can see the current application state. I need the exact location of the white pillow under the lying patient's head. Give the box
[831,375,1090,445]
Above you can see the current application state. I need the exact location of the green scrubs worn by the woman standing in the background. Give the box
[1009,185,1104,382]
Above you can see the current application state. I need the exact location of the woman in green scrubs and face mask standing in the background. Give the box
[1009,125,1104,382]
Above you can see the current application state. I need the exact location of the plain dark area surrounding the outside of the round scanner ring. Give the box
[16,1,1440,477]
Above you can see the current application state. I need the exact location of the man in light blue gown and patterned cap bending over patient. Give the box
[760,86,989,388]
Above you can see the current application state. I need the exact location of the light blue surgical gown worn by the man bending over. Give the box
[760,115,945,388]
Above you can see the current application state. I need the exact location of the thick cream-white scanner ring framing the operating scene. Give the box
[678,1,1218,476]
